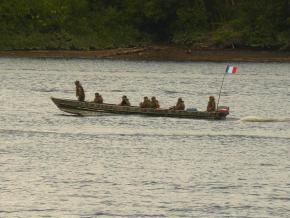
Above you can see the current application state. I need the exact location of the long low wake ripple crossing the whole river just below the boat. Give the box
[0,127,290,139]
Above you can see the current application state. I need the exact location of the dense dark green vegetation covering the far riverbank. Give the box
[0,0,290,50]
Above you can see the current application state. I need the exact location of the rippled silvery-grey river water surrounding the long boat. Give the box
[0,58,290,218]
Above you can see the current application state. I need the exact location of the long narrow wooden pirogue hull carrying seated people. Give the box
[51,97,229,120]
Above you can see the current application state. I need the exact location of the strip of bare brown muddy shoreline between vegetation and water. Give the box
[0,46,290,62]
